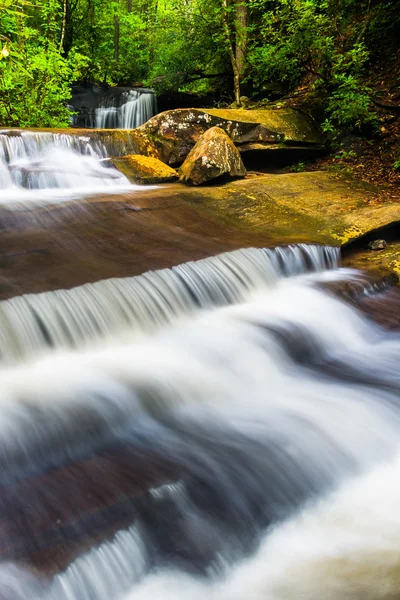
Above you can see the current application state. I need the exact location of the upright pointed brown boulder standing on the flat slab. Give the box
[180,127,246,185]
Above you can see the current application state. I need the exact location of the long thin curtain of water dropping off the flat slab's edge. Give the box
[0,244,339,361]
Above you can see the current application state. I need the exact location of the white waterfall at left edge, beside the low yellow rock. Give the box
[0,130,129,199]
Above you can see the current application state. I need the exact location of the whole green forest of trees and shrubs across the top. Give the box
[0,0,400,149]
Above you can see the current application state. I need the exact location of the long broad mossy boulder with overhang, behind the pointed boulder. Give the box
[137,108,325,165]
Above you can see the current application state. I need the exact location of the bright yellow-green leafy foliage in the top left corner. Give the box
[0,0,86,127]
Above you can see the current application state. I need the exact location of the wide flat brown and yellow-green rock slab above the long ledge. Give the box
[0,172,400,299]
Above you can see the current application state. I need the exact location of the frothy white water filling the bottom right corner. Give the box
[119,458,400,600]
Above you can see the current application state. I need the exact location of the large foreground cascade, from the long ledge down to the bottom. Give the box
[0,246,400,600]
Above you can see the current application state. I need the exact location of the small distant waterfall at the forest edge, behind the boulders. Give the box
[95,90,157,129]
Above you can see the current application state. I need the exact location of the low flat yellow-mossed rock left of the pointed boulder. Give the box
[111,154,179,184]
